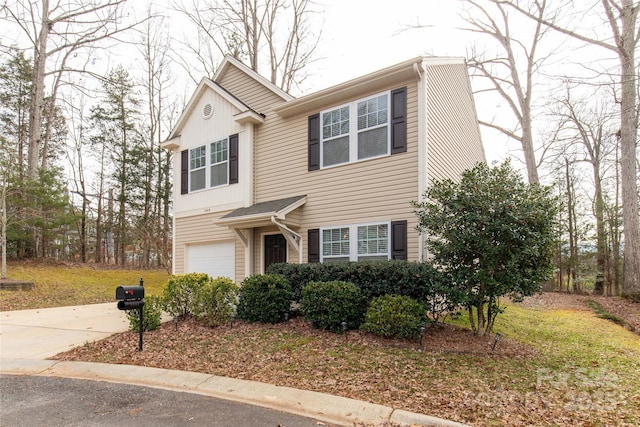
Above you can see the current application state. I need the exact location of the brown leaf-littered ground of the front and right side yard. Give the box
[55,293,640,427]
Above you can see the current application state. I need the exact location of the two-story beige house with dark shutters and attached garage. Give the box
[164,57,485,282]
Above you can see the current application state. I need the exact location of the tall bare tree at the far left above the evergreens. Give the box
[0,0,140,179]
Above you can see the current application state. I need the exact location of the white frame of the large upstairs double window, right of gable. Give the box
[320,91,391,169]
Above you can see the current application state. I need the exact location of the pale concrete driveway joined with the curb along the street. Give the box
[0,302,470,427]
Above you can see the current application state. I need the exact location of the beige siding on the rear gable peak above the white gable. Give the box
[218,66,283,113]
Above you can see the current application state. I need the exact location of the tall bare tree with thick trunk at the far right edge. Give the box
[500,0,640,300]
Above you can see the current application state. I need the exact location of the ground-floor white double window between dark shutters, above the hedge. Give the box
[321,223,390,262]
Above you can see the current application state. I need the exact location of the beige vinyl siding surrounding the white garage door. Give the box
[173,211,245,283]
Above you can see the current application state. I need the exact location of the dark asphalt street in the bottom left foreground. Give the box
[0,375,331,427]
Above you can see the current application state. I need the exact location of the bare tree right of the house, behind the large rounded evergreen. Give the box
[463,0,548,183]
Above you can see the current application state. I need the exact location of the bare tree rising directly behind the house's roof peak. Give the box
[174,0,320,92]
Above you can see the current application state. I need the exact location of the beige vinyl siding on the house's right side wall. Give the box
[425,65,485,181]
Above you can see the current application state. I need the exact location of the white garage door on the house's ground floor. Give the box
[186,242,236,281]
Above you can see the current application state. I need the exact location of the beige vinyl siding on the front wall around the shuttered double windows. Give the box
[255,78,418,265]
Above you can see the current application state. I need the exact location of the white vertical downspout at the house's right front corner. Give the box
[413,62,429,261]
